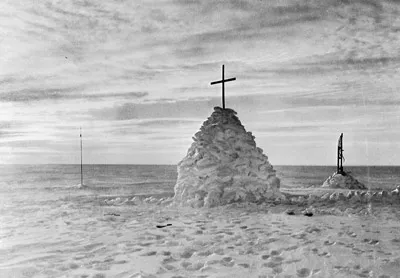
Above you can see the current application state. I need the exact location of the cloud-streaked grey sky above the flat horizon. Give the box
[0,0,400,165]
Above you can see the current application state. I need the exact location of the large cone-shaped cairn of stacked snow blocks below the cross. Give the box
[174,107,282,207]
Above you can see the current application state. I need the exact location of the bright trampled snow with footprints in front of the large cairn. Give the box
[0,190,400,278]
